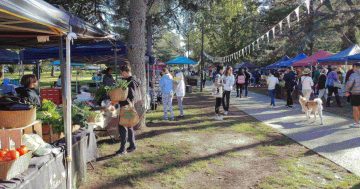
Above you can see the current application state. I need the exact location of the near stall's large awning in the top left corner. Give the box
[0,0,113,48]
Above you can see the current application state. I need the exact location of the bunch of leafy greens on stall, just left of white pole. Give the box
[37,100,64,133]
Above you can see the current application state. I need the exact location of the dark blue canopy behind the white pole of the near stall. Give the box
[20,41,127,61]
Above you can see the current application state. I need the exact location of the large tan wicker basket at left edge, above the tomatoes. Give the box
[0,108,36,129]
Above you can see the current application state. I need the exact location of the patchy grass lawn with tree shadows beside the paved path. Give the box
[81,93,360,189]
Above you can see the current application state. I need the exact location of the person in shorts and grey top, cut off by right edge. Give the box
[345,63,360,128]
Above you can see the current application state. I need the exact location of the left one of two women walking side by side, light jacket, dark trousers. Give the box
[212,65,224,120]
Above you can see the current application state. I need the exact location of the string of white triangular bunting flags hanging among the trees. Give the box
[204,0,316,63]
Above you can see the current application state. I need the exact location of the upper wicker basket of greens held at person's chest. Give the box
[105,79,130,102]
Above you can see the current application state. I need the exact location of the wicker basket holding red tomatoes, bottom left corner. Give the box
[0,151,32,180]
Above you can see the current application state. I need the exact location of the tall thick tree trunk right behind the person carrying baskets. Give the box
[127,0,147,129]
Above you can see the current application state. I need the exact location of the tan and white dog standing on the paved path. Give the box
[299,96,323,125]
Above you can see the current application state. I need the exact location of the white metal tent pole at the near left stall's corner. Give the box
[64,27,74,189]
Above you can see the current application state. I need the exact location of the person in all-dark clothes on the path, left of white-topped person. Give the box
[284,67,296,108]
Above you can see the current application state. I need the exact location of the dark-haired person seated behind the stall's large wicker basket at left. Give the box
[15,74,41,107]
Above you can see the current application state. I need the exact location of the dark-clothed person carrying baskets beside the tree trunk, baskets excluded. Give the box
[116,65,140,156]
